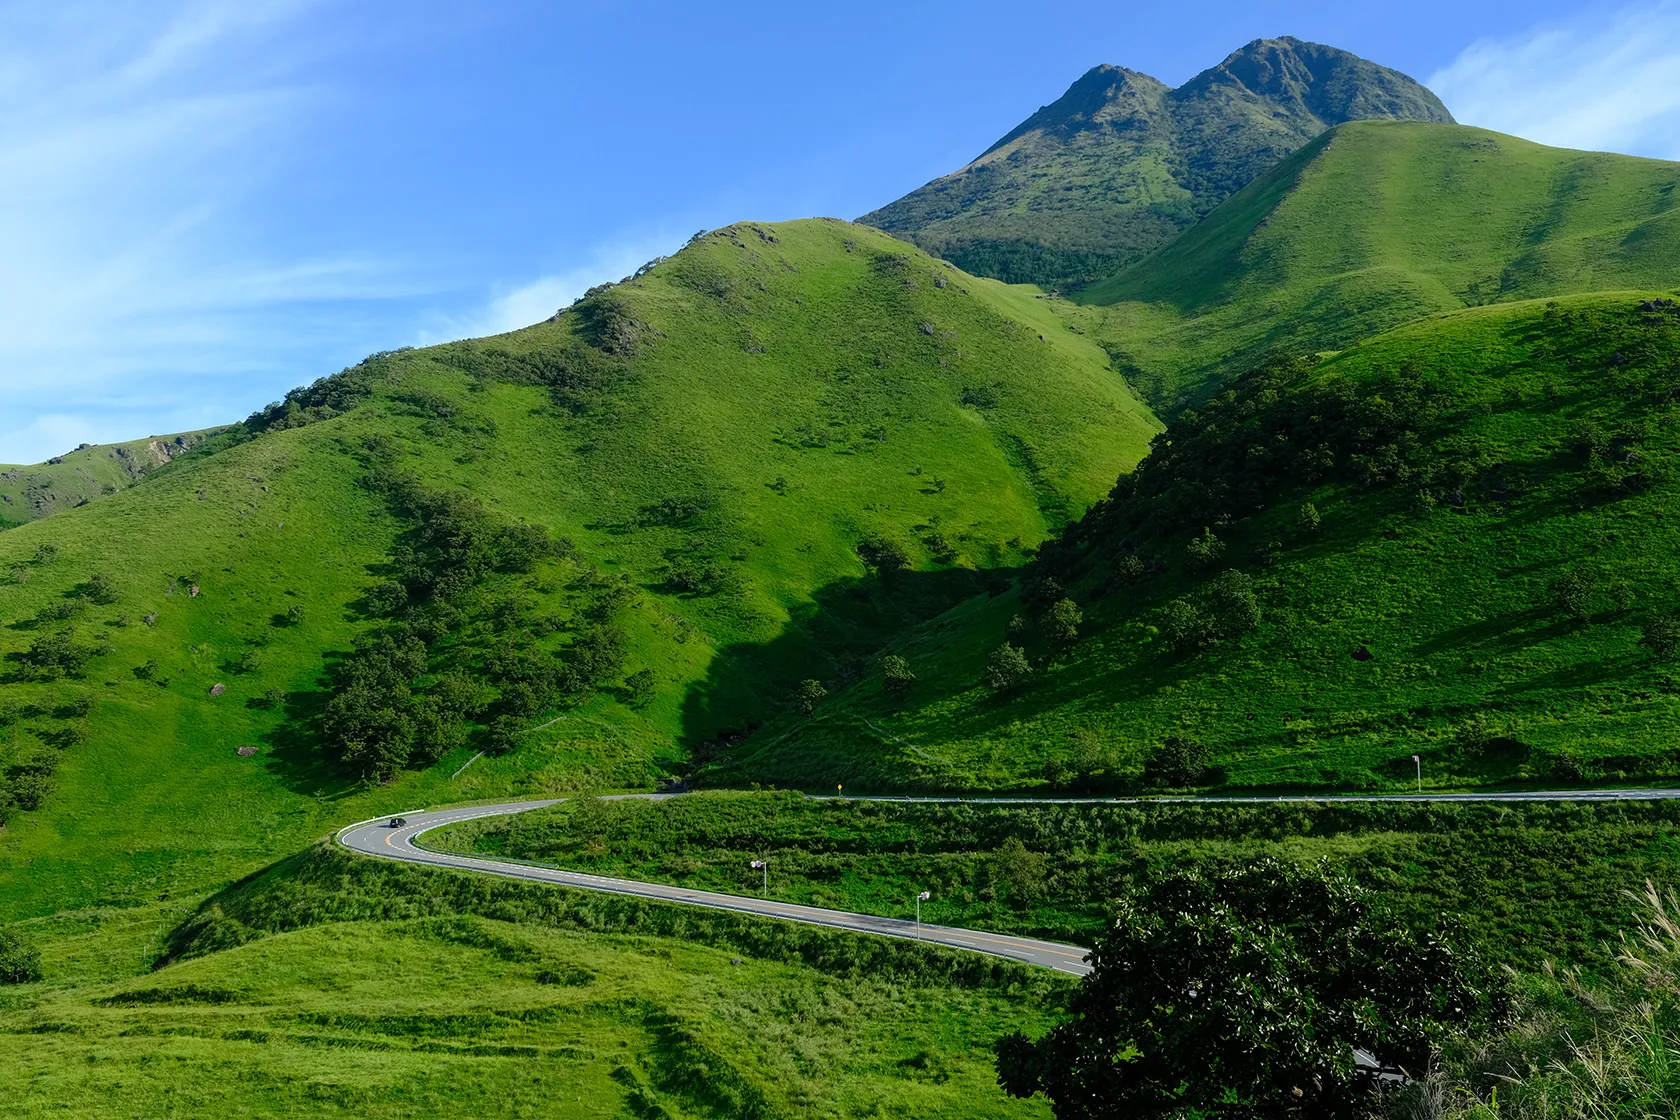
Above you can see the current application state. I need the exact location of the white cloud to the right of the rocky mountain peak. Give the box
[1428,0,1680,160]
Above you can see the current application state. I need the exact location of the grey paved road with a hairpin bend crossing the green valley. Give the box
[338,789,1680,976]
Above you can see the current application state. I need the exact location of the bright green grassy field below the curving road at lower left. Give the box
[0,910,1048,1118]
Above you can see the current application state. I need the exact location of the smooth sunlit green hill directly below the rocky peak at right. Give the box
[1058,123,1680,410]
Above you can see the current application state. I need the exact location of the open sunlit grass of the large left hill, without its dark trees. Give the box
[0,214,1152,915]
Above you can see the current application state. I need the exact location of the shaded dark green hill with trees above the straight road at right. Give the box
[729,294,1680,791]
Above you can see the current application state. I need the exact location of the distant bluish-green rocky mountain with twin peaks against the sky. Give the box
[858,37,1452,284]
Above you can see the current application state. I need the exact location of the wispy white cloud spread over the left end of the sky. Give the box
[0,0,411,462]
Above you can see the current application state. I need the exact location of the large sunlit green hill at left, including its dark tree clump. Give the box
[0,222,1156,913]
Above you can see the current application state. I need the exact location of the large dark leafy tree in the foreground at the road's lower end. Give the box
[996,860,1510,1120]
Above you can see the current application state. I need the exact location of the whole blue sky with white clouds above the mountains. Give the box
[0,0,1680,462]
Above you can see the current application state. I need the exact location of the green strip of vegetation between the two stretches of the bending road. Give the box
[425,793,1680,967]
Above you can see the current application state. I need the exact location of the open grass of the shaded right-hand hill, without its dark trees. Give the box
[735,296,1680,791]
